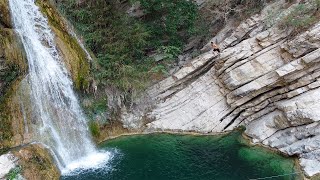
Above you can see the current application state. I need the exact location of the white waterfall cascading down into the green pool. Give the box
[9,0,110,172]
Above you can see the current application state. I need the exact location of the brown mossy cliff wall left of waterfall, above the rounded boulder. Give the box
[0,0,28,152]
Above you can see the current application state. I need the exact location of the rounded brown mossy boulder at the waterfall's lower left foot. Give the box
[13,145,60,180]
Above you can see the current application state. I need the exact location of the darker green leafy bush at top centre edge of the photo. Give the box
[137,0,199,47]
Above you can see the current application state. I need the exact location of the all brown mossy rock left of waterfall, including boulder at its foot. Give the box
[0,0,59,179]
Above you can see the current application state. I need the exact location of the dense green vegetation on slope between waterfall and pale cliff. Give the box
[59,0,198,91]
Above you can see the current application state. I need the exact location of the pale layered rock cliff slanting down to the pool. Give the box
[124,1,320,176]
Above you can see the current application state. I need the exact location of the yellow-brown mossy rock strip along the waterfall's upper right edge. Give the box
[37,0,90,90]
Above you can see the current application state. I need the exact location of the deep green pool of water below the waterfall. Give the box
[61,132,300,180]
